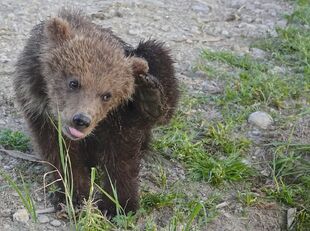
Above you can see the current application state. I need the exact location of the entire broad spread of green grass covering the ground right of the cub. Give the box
[153,0,310,230]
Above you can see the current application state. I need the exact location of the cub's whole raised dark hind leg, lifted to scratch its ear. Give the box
[133,40,179,125]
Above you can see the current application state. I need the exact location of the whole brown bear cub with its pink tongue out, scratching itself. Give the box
[14,10,178,215]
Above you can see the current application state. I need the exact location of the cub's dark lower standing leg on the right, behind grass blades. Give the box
[98,159,139,216]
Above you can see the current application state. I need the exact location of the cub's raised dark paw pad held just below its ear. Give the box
[135,74,165,119]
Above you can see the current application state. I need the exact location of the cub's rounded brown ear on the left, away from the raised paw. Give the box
[44,18,72,44]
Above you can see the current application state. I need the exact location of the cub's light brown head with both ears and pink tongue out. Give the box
[41,18,148,140]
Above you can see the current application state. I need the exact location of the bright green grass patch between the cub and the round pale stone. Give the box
[152,93,254,185]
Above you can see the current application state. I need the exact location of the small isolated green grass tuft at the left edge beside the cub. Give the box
[0,129,30,152]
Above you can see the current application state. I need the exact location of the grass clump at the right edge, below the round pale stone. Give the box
[266,143,310,230]
